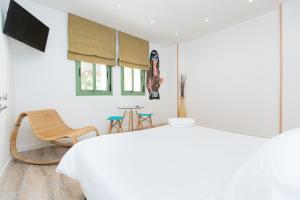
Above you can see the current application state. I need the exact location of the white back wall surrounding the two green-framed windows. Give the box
[11,0,176,150]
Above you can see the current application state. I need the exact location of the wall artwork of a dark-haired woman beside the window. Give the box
[147,50,163,100]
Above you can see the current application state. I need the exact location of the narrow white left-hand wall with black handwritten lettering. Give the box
[0,1,14,177]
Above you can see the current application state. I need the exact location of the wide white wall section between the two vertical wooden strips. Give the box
[179,11,279,137]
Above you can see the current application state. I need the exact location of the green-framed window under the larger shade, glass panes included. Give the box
[75,61,112,96]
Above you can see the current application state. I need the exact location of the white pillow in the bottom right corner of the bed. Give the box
[221,129,300,200]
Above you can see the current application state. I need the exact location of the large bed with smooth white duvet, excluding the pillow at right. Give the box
[57,126,267,200]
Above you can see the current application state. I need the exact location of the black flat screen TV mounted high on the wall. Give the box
[3,0,49,52]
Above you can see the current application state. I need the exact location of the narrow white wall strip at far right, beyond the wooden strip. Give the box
[283,0,300,130]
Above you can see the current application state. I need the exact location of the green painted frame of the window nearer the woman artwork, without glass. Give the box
[121,67,146,96]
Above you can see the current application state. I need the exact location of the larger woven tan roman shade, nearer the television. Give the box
[68,14,116,66]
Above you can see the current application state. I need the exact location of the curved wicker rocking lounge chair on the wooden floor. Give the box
[10,109,99,165]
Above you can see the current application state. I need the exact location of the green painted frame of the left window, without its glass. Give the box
[75,61,113,96]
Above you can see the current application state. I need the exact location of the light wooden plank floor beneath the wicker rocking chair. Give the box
[0,147,84,200]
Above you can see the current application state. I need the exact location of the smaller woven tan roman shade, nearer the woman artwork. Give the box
[118,32,149,70]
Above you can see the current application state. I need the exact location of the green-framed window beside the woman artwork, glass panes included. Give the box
[121,67,145,95]
